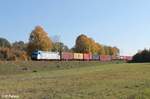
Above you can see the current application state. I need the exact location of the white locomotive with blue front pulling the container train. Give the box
[31,51,60,60]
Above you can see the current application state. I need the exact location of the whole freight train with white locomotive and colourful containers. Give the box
[31,51,132,62]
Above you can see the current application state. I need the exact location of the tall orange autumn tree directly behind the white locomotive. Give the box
[27,26,52,55]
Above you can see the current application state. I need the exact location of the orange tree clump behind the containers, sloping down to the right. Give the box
[73,34,119,55]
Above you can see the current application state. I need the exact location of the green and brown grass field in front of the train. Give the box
[0,62,150,99]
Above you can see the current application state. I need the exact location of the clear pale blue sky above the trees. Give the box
[0,0,150,55]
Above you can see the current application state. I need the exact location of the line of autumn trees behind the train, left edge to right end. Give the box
[0,26,119,60]
